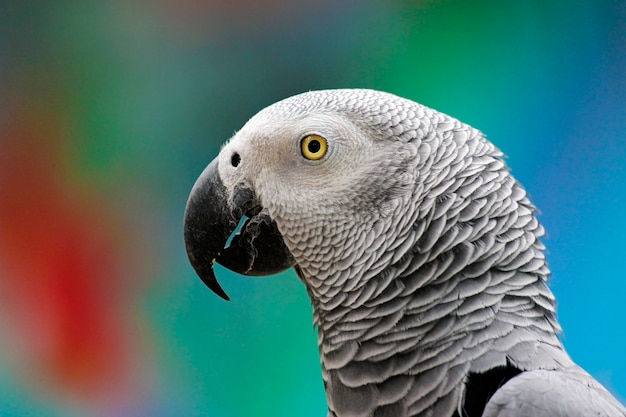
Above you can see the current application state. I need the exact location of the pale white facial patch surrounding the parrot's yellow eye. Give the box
[220,113,377,215]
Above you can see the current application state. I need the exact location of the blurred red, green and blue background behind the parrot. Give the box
[0,0,626,417]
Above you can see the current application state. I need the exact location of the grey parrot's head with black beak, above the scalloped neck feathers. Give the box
[184,90,499,299]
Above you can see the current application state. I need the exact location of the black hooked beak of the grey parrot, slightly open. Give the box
[184,158,295,300]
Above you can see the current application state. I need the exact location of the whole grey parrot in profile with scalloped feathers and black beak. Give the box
[184,89,626,417]
